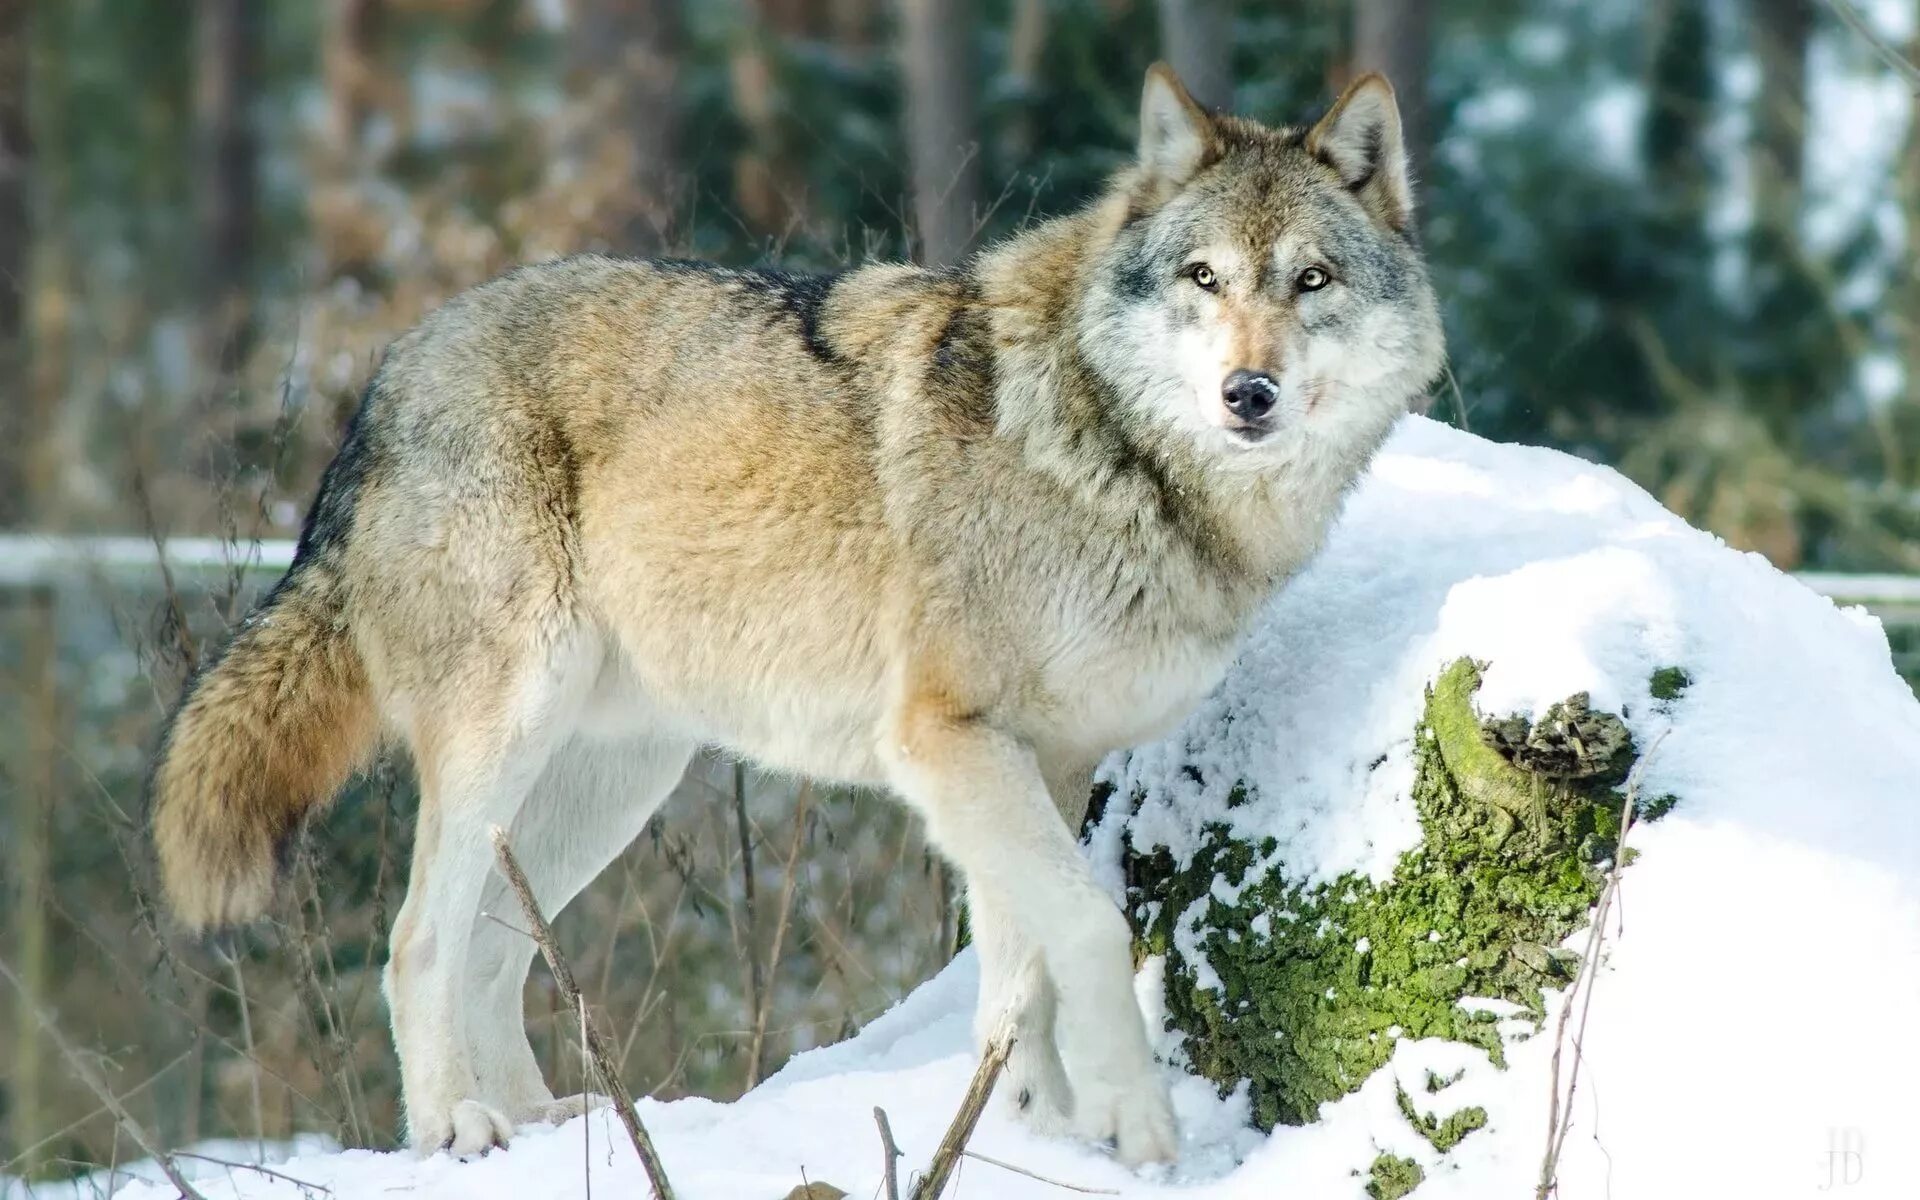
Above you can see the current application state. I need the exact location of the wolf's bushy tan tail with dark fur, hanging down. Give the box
[148,555,378,933]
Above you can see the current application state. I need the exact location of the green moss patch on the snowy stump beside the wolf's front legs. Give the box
[1127,659,1666,1146]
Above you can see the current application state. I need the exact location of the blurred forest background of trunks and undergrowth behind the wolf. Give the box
[0,0,1920,1192]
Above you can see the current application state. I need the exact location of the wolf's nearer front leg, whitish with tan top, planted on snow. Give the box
[887,703,1177,1164]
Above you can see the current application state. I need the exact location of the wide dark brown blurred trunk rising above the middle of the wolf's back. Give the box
[566,0,682,253]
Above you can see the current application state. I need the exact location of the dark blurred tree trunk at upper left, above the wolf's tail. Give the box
[194,0,259,378]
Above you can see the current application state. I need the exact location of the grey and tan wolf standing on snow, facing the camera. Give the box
[150,65,1444,1164]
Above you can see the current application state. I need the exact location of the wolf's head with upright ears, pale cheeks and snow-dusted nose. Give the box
[1079,65,1444,468]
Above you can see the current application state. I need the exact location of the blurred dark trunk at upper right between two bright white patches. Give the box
[1751,0,1814,238]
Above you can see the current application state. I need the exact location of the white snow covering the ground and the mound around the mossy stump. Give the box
[101,419,1920,1200]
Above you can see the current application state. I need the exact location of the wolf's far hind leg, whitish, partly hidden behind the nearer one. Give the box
[467,735,693,1125]
